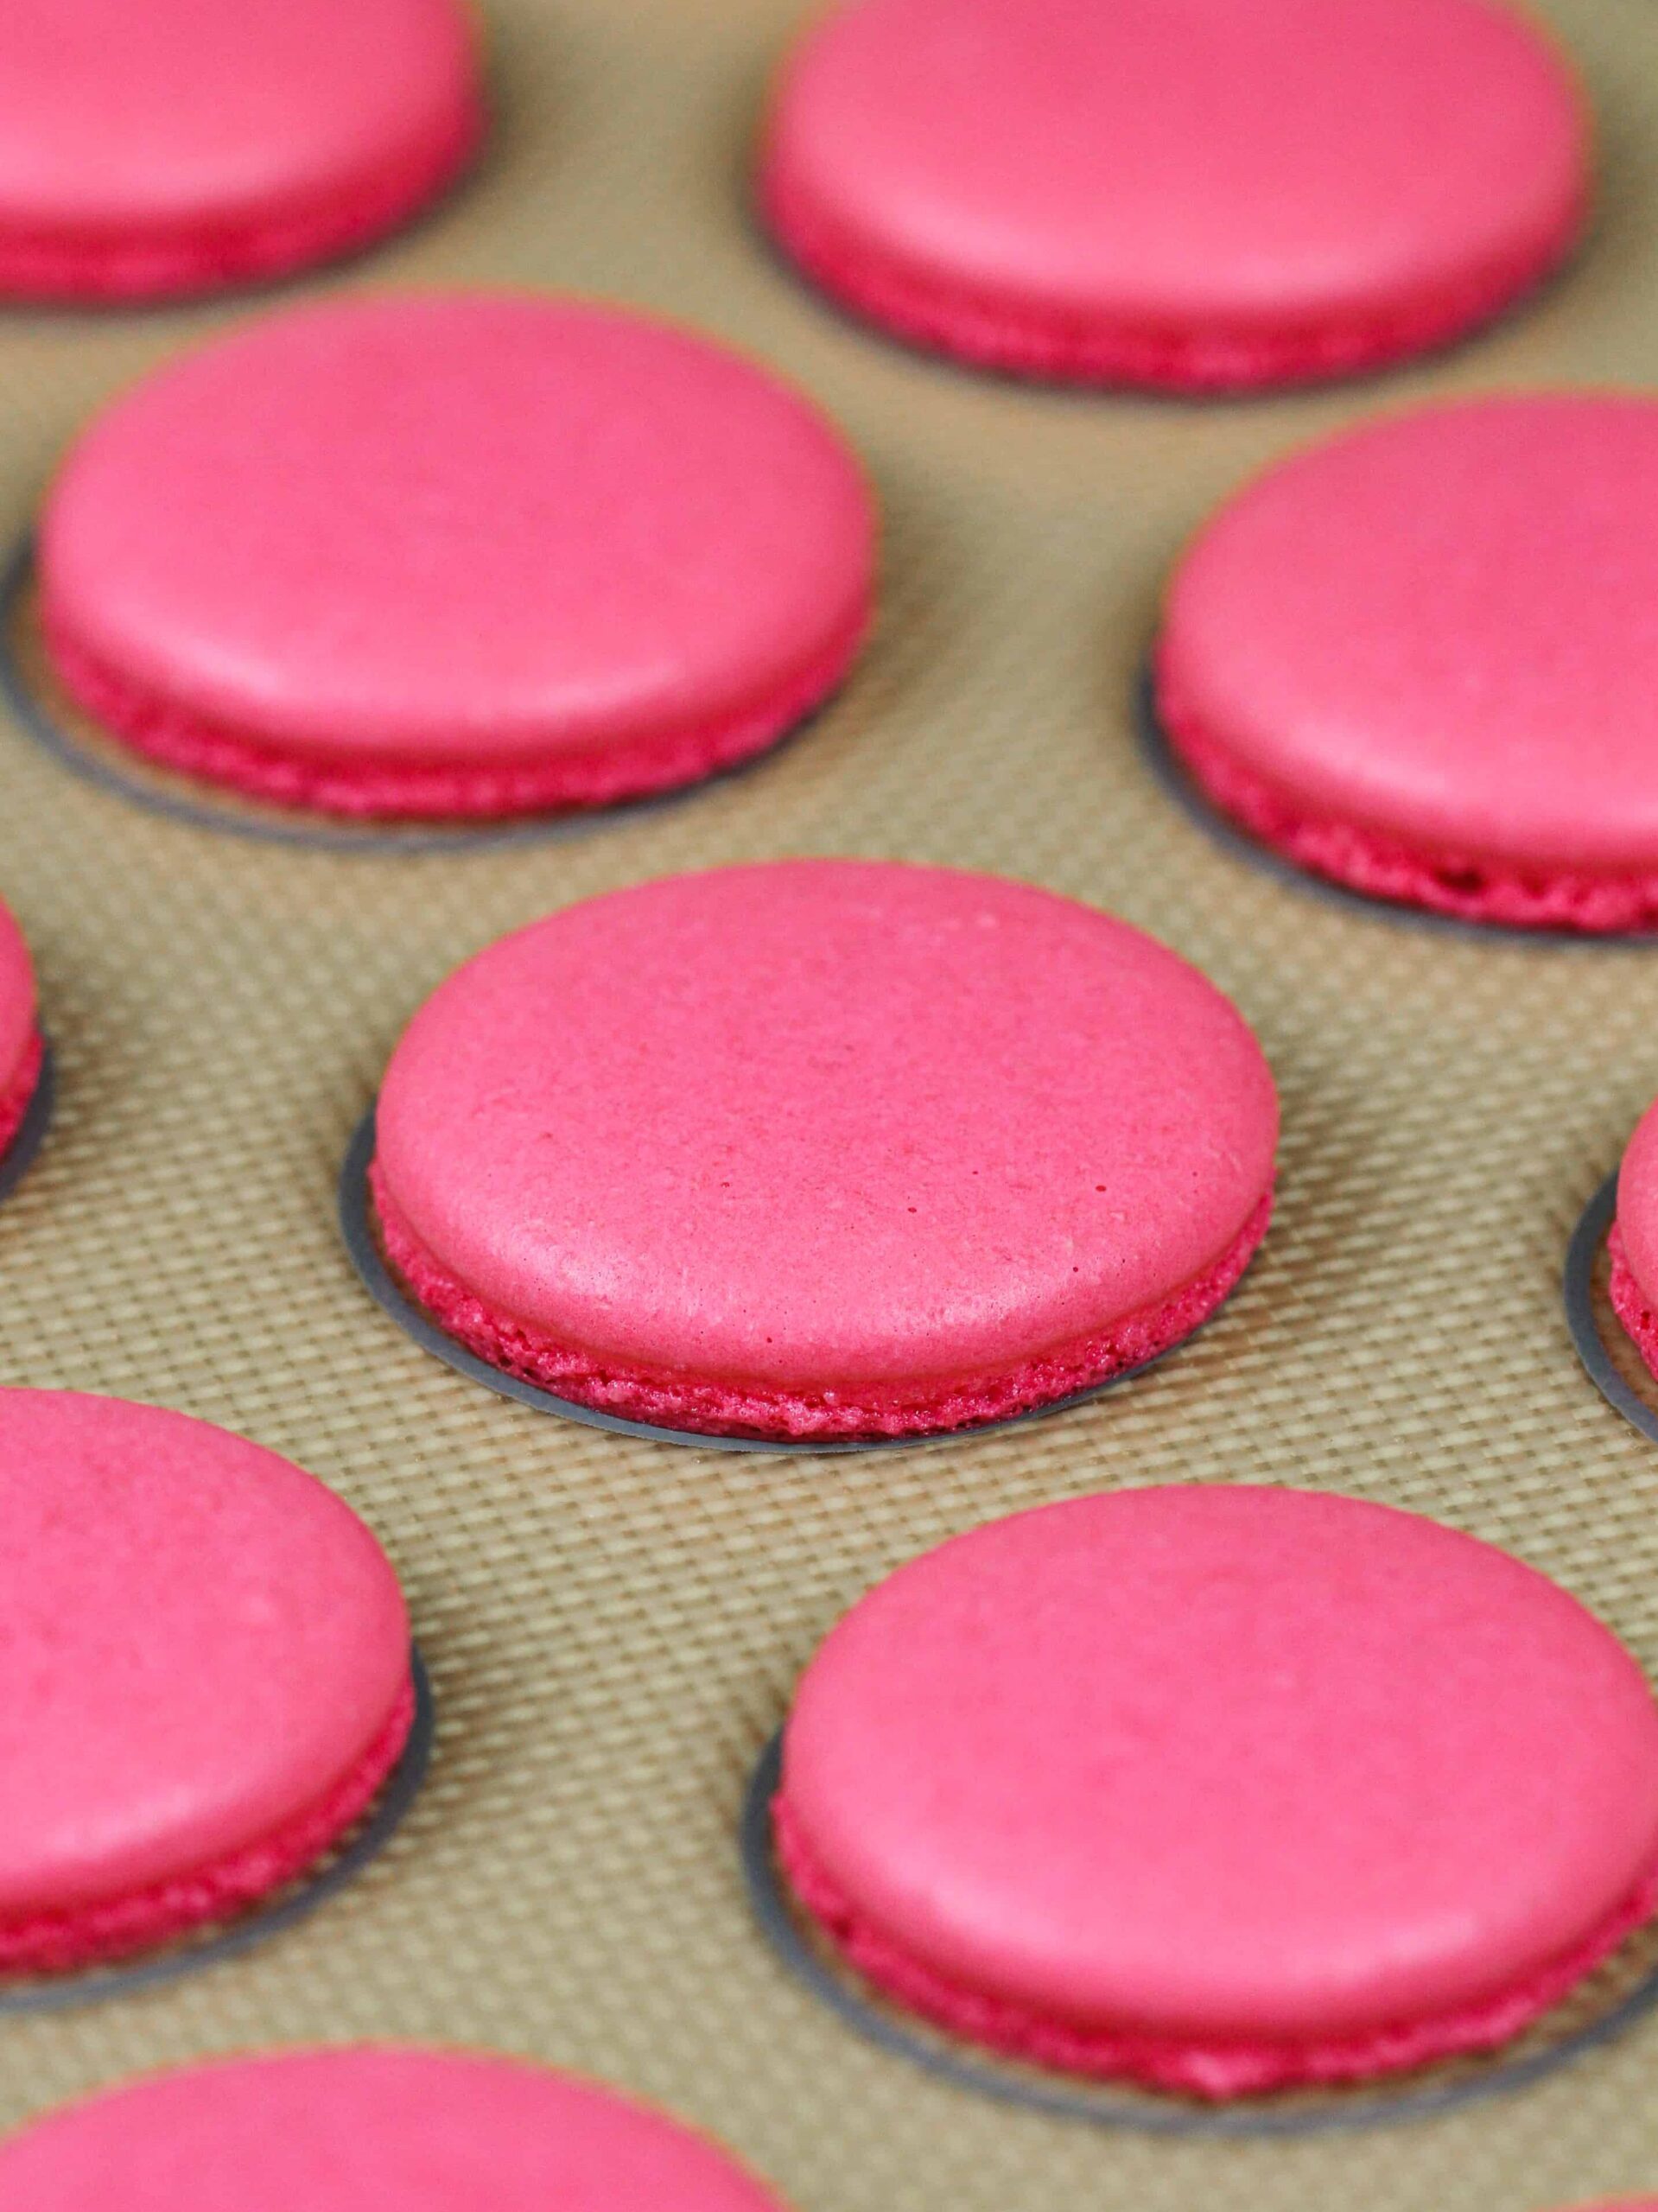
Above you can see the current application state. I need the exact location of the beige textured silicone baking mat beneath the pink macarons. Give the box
[0,0,1658,2212]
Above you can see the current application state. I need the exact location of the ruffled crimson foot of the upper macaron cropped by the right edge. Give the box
[1154,651,1658,936]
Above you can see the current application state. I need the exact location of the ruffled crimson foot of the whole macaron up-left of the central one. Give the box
[40,600,871,821]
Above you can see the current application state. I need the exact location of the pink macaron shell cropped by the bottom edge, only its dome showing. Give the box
[0,2044,783,2212]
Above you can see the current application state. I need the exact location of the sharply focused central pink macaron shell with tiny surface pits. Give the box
[372,861,1278,1440]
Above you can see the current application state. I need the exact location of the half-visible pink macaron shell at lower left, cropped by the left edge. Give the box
[0,1389,416,1981]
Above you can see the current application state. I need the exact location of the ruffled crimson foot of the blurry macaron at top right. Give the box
[759,155,1590,396]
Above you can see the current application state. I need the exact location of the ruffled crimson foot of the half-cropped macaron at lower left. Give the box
[0,1676,418,1975]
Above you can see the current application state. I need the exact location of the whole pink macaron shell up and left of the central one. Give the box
[37,292,875,817]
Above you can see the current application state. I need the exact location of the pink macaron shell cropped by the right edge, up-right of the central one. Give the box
[1154,391,1658,931]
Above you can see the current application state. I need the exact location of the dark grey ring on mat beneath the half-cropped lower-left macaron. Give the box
[0,1650,438,2024]
